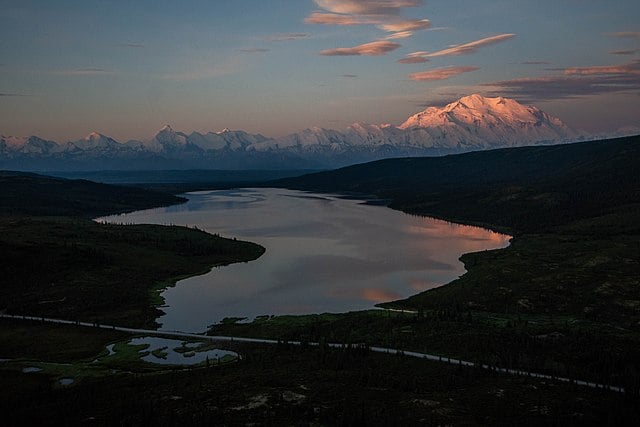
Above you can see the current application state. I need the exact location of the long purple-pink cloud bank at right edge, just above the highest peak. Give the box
[483,60,640,102]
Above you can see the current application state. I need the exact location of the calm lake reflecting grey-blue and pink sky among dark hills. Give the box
[100,189,510,331]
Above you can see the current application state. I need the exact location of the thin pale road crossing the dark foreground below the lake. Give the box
[0,313,624,393]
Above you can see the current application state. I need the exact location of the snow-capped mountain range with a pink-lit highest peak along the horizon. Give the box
[0,94,585,171]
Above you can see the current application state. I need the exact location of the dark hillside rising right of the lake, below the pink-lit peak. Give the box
[275,136,640,233]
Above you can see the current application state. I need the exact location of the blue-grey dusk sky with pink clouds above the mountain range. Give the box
[0,0,640,142]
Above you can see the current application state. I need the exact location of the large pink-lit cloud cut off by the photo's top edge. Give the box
[305,0,431,39]
